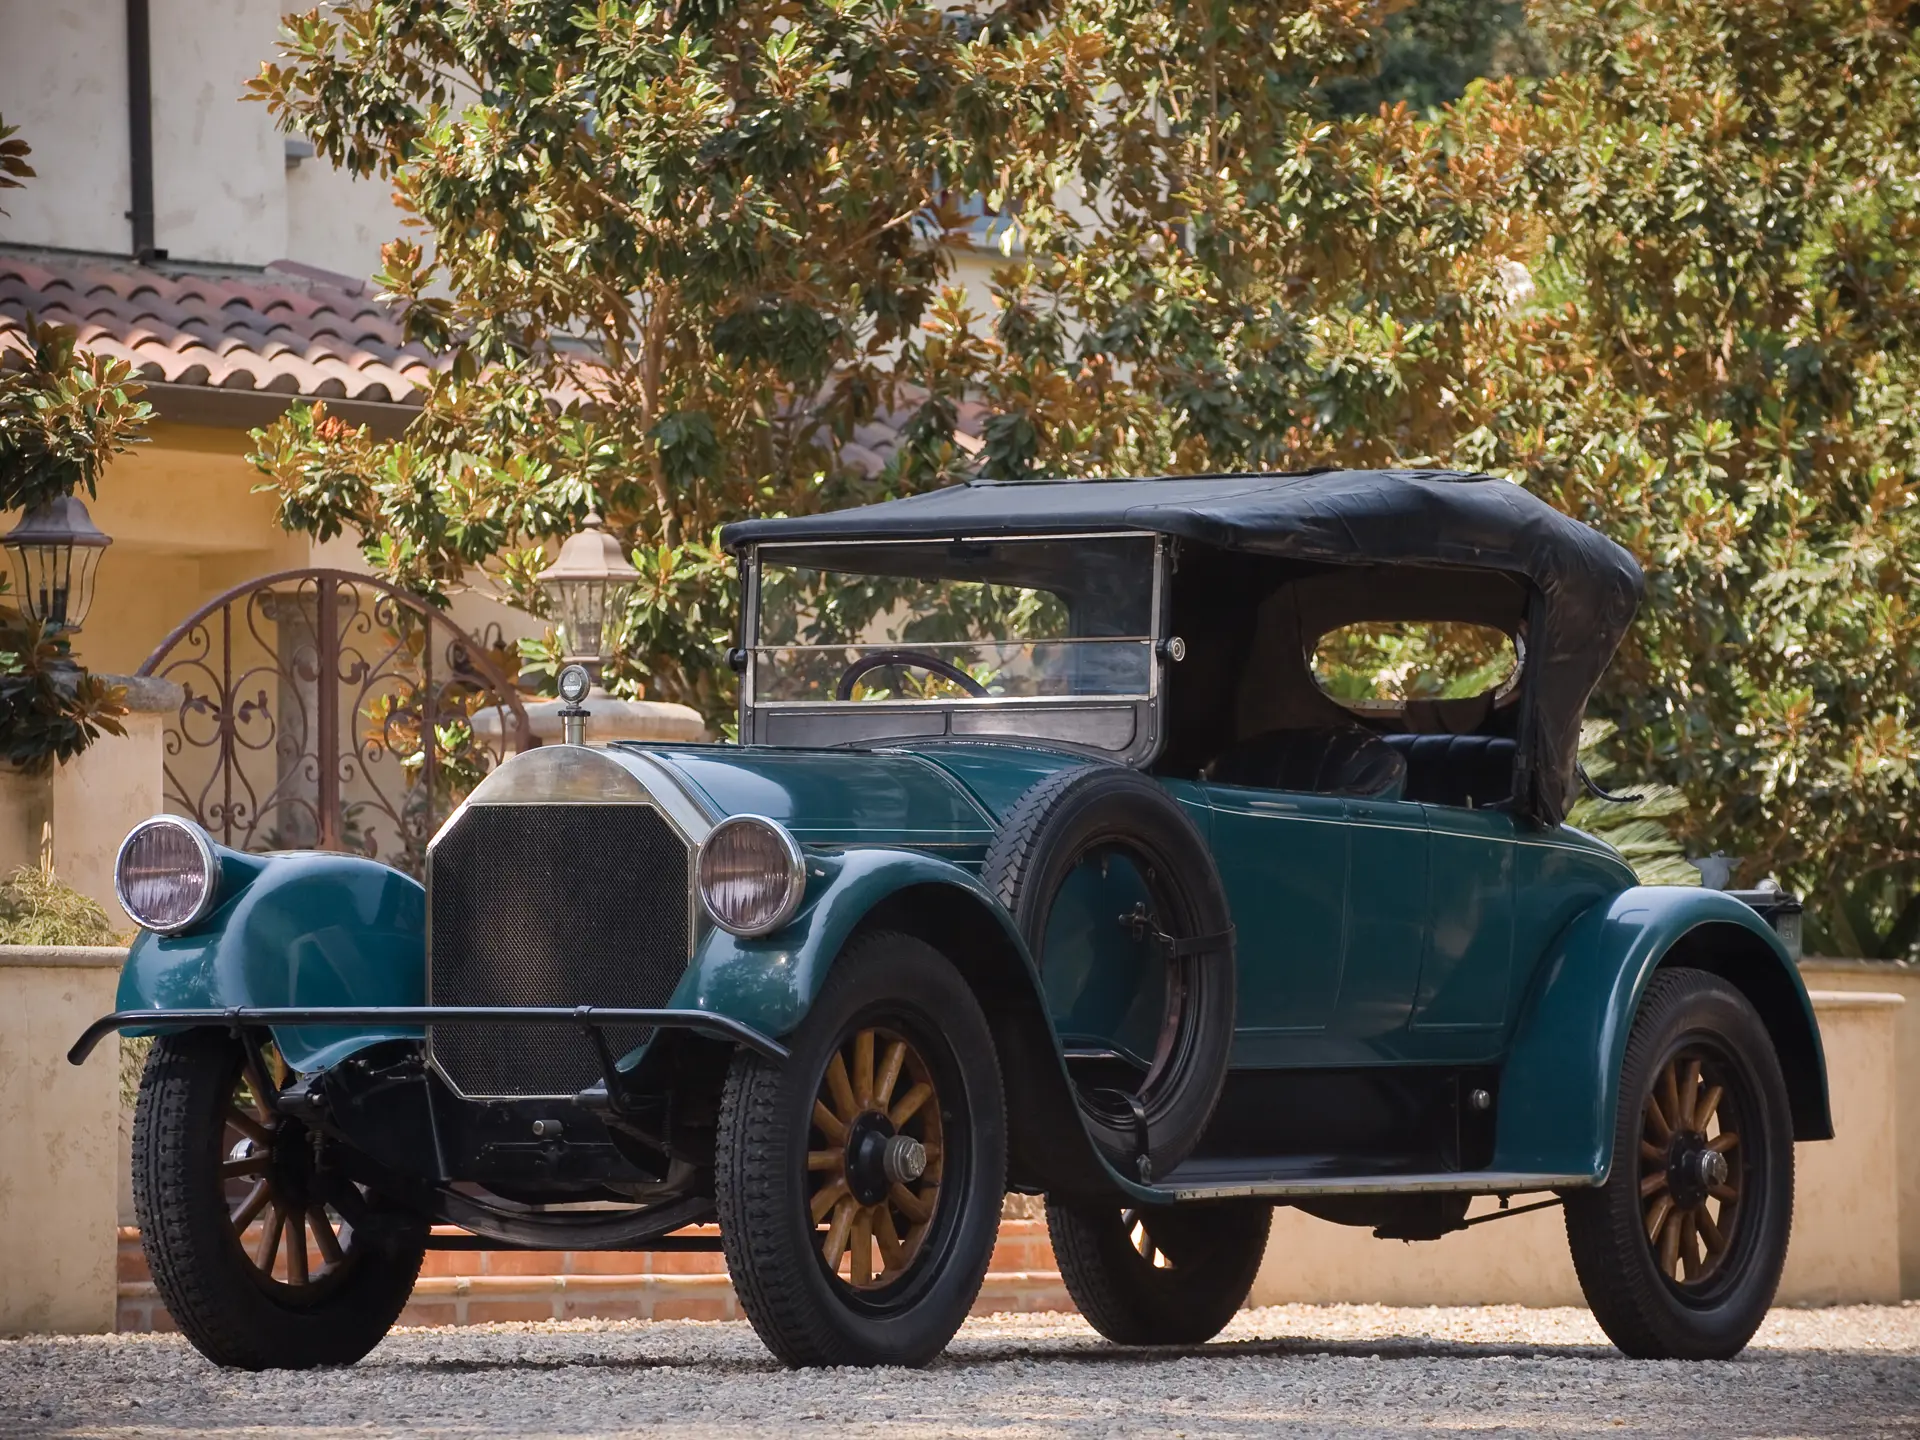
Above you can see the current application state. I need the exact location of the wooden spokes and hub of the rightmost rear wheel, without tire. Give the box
[1640,1050,1743,1290]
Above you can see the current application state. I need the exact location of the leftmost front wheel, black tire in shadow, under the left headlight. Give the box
[132,1029,426,1371]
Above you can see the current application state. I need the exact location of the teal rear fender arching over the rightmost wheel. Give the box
[1494,885,1834,1185]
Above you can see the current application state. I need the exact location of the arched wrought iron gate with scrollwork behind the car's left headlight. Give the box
[140,570,534,874]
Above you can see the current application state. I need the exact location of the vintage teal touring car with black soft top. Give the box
[75,470,1832,1367]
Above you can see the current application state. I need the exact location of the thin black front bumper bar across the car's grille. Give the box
[67,1004,787,1079]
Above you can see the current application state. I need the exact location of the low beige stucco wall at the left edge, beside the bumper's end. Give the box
[0,947,125,1334]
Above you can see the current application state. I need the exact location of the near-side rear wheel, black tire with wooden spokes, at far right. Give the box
[1567,970,1793,1359]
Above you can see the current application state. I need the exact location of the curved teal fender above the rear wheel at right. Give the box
[1494,885,1826,1183]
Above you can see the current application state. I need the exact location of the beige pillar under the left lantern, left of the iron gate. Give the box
[50,676,184,927]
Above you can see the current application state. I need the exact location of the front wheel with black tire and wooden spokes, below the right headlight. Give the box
[714,931,1006,1365]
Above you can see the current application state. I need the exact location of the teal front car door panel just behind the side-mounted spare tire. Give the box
[1206,781,1348,1066]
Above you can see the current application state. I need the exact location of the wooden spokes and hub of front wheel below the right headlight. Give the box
[806,1027,945,1290]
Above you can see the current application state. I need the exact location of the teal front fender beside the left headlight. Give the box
[113,849,426,1071]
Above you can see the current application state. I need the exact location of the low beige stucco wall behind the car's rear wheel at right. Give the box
[1252,975,1920,1306]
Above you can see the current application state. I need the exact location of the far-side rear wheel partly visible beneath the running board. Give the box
[1046,1200,1273,1346]
